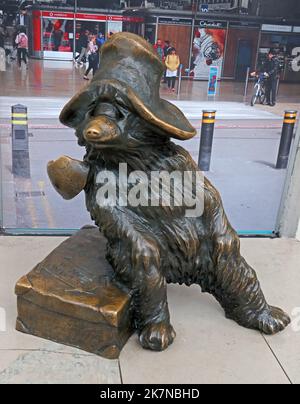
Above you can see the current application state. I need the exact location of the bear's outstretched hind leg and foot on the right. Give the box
[212,230,290,334]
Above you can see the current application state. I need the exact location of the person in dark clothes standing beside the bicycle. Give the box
[264,49,281,107]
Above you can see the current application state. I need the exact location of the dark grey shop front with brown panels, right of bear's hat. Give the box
[132,10,300,83]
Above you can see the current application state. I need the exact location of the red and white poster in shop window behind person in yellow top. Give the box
[192,28,227,80]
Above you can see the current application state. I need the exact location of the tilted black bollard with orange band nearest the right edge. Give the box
[276,111,297,170]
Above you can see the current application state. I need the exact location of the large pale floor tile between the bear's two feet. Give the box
[120,286,288,384]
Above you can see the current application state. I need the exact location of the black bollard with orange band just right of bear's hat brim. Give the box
[198,111,216,171]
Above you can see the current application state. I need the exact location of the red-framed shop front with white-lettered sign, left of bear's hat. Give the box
[29,10,144,61]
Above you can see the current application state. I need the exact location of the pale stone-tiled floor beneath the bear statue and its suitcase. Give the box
[0,237,300,384]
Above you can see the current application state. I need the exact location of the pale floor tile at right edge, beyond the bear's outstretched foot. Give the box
[243,239,300,384]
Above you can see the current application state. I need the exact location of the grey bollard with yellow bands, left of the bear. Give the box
[11,104,30,178]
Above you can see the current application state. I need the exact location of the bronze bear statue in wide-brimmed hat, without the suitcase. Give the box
[48,33,290,351]
